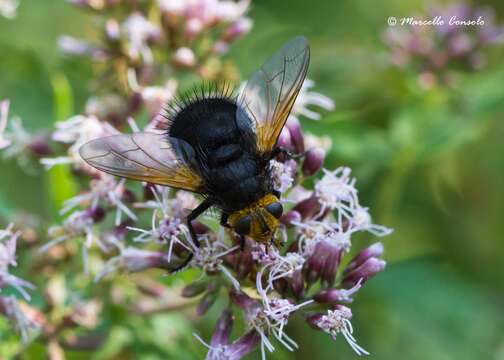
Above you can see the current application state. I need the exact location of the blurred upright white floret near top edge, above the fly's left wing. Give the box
[122,12,160,64]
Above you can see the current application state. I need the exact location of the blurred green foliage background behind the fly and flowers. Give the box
[0,0,504,360]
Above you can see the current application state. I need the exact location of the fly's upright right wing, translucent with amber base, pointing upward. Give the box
[237,36,310,153]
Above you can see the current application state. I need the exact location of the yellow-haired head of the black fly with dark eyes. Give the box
[228,194,283,243]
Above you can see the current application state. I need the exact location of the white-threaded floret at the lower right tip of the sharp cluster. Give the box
[316,305,369,355]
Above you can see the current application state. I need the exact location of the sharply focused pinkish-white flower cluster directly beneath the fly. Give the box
[82,103,391,359]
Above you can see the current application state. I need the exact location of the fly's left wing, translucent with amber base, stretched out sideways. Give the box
[79,132,202,192]
